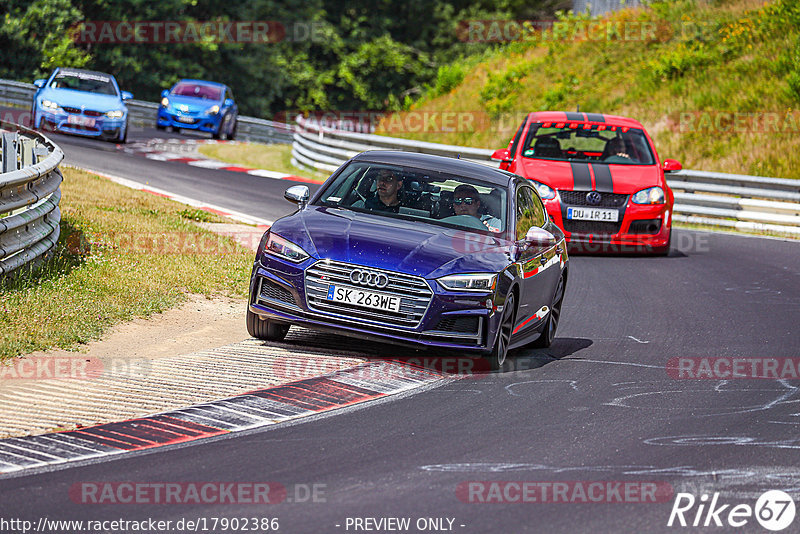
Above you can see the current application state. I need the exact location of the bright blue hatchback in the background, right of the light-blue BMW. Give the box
[156,80,239,139]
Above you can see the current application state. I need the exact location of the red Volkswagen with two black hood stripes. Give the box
[492,111,681,254]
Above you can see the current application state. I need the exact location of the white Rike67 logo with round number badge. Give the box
[667,490,796,532]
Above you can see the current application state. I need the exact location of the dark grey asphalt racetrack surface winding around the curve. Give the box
[0,122,800,533]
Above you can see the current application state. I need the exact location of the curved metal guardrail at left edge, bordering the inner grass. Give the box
[0,121,64,277]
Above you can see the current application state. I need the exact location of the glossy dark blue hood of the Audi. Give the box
[270,206,510,278]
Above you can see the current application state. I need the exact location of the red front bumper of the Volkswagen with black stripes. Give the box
[545,198,672,254]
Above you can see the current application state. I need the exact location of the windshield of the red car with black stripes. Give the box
[522,121,655,165]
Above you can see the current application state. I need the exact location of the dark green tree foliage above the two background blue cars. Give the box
[0,0,569,117]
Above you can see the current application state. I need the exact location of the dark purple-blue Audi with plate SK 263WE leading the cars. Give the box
[247,151,569,369]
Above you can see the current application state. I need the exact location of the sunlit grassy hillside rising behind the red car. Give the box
[376,0,800,178]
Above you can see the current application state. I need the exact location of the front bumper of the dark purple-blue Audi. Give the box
[249,258,499,355]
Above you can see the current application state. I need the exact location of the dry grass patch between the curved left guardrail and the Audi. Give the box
[0,168,253,361]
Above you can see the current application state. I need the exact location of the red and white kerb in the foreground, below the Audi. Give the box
[0,360,456,475]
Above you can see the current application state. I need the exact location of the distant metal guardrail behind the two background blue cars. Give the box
[0,79,294,143]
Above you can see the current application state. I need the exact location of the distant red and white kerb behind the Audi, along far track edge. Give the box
[122,139,316,183]
